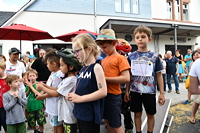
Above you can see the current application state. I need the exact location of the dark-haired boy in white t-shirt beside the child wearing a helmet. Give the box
[37,49,64,133]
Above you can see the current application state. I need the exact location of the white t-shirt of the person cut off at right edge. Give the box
[189,59,200,81]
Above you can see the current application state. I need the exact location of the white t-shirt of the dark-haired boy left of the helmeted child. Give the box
[46,71,64,116]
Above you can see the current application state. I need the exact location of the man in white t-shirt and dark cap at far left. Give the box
[6,47,26,89]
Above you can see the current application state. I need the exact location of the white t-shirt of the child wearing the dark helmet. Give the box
[57,76,77,124]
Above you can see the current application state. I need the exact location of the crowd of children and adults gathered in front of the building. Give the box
[0,25,200,133]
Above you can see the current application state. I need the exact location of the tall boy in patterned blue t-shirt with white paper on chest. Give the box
[125,26,165,133]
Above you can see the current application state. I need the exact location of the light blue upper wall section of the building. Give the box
[26,0,151,19]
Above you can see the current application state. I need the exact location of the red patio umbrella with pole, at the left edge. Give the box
[0,24,54,50]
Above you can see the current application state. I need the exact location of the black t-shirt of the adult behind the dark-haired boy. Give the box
[31,57,51,81]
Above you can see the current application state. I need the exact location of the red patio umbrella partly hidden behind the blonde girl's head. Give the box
[55,29,98,42]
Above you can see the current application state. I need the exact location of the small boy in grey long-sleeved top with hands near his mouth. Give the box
[3,75,27,133]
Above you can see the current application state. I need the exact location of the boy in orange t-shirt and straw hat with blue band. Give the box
[96,29,130,133]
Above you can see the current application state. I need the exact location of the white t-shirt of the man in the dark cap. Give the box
[6,60,26,91]
